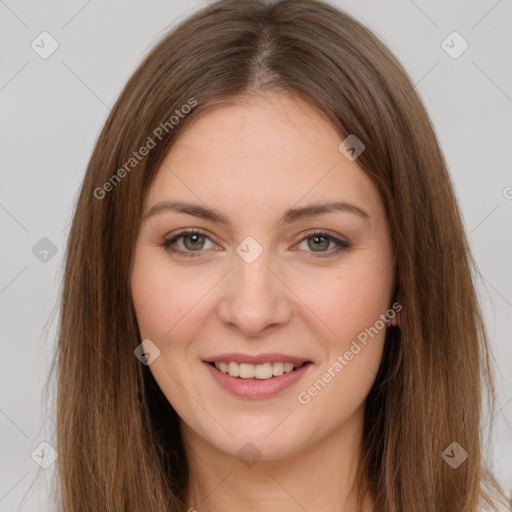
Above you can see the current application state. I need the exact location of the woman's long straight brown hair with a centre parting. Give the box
[48,0,499,512]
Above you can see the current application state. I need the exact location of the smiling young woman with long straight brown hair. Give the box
[49,0,508,512]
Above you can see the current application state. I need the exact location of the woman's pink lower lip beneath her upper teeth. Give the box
[204,363,312,400]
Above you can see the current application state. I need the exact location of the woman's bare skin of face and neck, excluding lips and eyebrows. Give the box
[131,93,394,512]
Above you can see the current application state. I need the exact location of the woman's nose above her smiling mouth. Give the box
[218,246,293,338]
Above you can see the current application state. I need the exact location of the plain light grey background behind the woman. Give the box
[0,0,512,512]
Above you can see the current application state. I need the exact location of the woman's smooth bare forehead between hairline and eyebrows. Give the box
[147,94,382,224]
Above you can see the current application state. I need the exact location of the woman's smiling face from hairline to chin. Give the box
[131,94,394,460]
